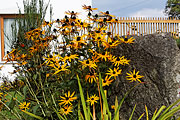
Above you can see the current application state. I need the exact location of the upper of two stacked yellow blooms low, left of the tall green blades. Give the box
[59,91,77,105]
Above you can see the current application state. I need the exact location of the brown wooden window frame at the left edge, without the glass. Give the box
[0,14,19,61]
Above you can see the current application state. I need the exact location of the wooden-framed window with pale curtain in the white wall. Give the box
[0,14,17,61]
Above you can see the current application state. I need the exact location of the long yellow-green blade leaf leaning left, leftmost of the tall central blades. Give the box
[77,75,88,120]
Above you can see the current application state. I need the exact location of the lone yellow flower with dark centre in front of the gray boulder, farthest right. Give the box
[126,69,144,82]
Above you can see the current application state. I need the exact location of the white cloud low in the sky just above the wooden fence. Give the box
[129,8,165,17]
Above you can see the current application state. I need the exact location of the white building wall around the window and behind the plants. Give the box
[0,0,92,82]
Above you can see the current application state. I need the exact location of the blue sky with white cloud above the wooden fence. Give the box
[92,0,167,17]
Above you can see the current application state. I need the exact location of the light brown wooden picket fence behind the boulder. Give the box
[109,17,180,38]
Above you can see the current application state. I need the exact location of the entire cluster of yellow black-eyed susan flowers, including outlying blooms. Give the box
[0,5,143,118]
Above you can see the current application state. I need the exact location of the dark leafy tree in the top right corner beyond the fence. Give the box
[165,0,180,18]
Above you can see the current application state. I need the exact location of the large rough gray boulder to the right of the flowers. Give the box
[109,33,180,120]
